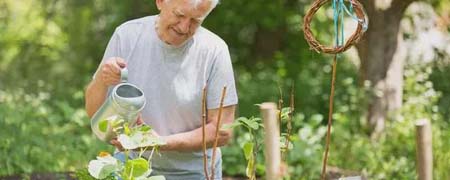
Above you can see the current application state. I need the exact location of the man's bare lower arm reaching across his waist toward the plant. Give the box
[161,105,235,151]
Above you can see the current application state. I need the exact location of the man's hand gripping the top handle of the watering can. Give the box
[95,57,127,87]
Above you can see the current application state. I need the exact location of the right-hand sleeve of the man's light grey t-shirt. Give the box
[207,46,238,109]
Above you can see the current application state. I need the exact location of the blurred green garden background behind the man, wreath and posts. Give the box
[0,0,450,179]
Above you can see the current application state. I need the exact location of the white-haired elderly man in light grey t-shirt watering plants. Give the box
[86,0,238,180]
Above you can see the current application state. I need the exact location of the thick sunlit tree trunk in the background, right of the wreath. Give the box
[357,0,414,135]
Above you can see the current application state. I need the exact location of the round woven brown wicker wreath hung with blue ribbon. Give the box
[303,0,365,54]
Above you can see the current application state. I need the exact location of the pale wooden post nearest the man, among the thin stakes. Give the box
[260,102,281,180]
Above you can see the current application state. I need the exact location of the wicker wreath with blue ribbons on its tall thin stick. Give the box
[303,0,368,180]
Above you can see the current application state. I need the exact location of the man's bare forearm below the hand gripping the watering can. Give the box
[85,80,108,117]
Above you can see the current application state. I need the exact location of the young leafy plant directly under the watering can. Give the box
[79,116,166,180]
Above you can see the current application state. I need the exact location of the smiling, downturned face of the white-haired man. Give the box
[156,0,211,46]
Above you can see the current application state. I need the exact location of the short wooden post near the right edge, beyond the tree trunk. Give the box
[416,119,433,180]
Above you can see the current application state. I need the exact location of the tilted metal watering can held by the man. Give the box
[91,68,146,142]
